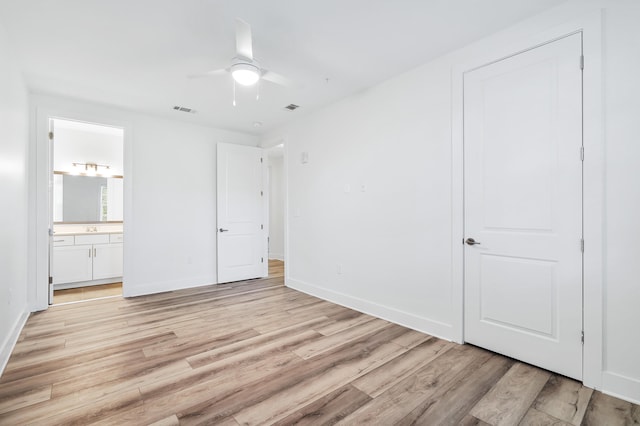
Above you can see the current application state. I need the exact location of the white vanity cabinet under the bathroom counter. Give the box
[52,233,123,288]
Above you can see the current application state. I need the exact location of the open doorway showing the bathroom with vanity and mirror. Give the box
[49,118,124,304]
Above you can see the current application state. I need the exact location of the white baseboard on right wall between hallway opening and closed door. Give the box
[285,278,454,340]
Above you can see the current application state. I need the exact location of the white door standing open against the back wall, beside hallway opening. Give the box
[217,143,268,283]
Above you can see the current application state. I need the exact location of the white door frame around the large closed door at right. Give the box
[451,10,605,389]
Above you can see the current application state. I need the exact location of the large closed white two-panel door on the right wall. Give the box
[464,34,582,379]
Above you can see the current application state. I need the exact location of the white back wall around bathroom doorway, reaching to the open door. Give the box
[32,95,258,309]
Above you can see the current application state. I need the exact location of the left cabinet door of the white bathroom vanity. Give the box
[51,246,93,284]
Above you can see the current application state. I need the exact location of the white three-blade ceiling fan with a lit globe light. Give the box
[189,18,291,87]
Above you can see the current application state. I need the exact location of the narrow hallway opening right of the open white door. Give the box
[267,144,285,278]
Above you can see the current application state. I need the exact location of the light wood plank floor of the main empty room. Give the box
[0,260,640,426]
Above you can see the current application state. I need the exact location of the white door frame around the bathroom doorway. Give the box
[28,99,133,311]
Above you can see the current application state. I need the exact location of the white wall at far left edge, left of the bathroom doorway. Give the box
[0,20,29,374]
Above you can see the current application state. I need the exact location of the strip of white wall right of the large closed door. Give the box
[603,2,640,403]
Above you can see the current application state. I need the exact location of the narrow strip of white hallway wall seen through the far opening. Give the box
[269,156,284,260]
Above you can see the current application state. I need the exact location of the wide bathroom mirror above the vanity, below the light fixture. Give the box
[53,172,123,223]
